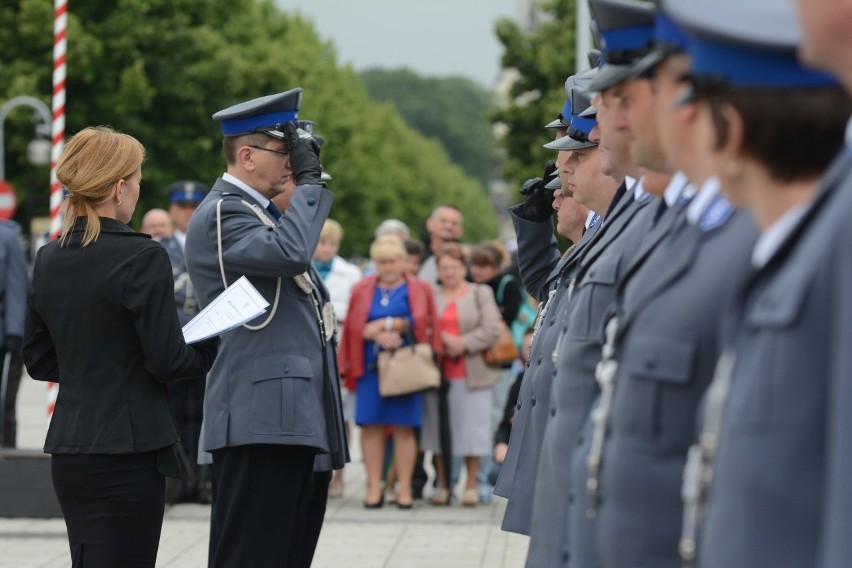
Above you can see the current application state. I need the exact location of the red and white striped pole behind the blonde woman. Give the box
[47,0,68,422]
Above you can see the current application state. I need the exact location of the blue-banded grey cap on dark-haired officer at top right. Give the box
[664,0,837,93]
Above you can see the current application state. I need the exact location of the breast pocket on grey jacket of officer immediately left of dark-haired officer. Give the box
[613,330,700,449]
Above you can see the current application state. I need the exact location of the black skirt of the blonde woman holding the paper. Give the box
[51,451,165,568]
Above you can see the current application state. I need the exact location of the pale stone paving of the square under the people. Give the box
[0,377,529,568]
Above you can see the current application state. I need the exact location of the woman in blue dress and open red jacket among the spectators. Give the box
[338,237,440,509]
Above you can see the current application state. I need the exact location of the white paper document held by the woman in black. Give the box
[183,276,269,343]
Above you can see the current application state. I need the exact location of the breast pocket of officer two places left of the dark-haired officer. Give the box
[568,252,621,339]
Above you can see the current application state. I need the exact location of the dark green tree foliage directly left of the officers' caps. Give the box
[491,0,576,201]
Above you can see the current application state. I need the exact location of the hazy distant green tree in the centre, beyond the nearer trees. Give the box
[359,69,497,187]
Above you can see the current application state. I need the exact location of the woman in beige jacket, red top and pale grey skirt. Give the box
[423,243,502,506]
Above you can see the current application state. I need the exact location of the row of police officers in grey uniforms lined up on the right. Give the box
[495,0,852,568]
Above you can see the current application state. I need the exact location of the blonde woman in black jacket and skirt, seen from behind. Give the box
[24,127,216,568]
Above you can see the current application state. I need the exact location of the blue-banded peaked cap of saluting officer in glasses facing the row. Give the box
[213,87,302,138]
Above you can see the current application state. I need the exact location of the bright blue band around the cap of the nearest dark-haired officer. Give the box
[689,38,836,87]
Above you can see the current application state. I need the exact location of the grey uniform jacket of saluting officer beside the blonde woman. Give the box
[186,179,348,469]
